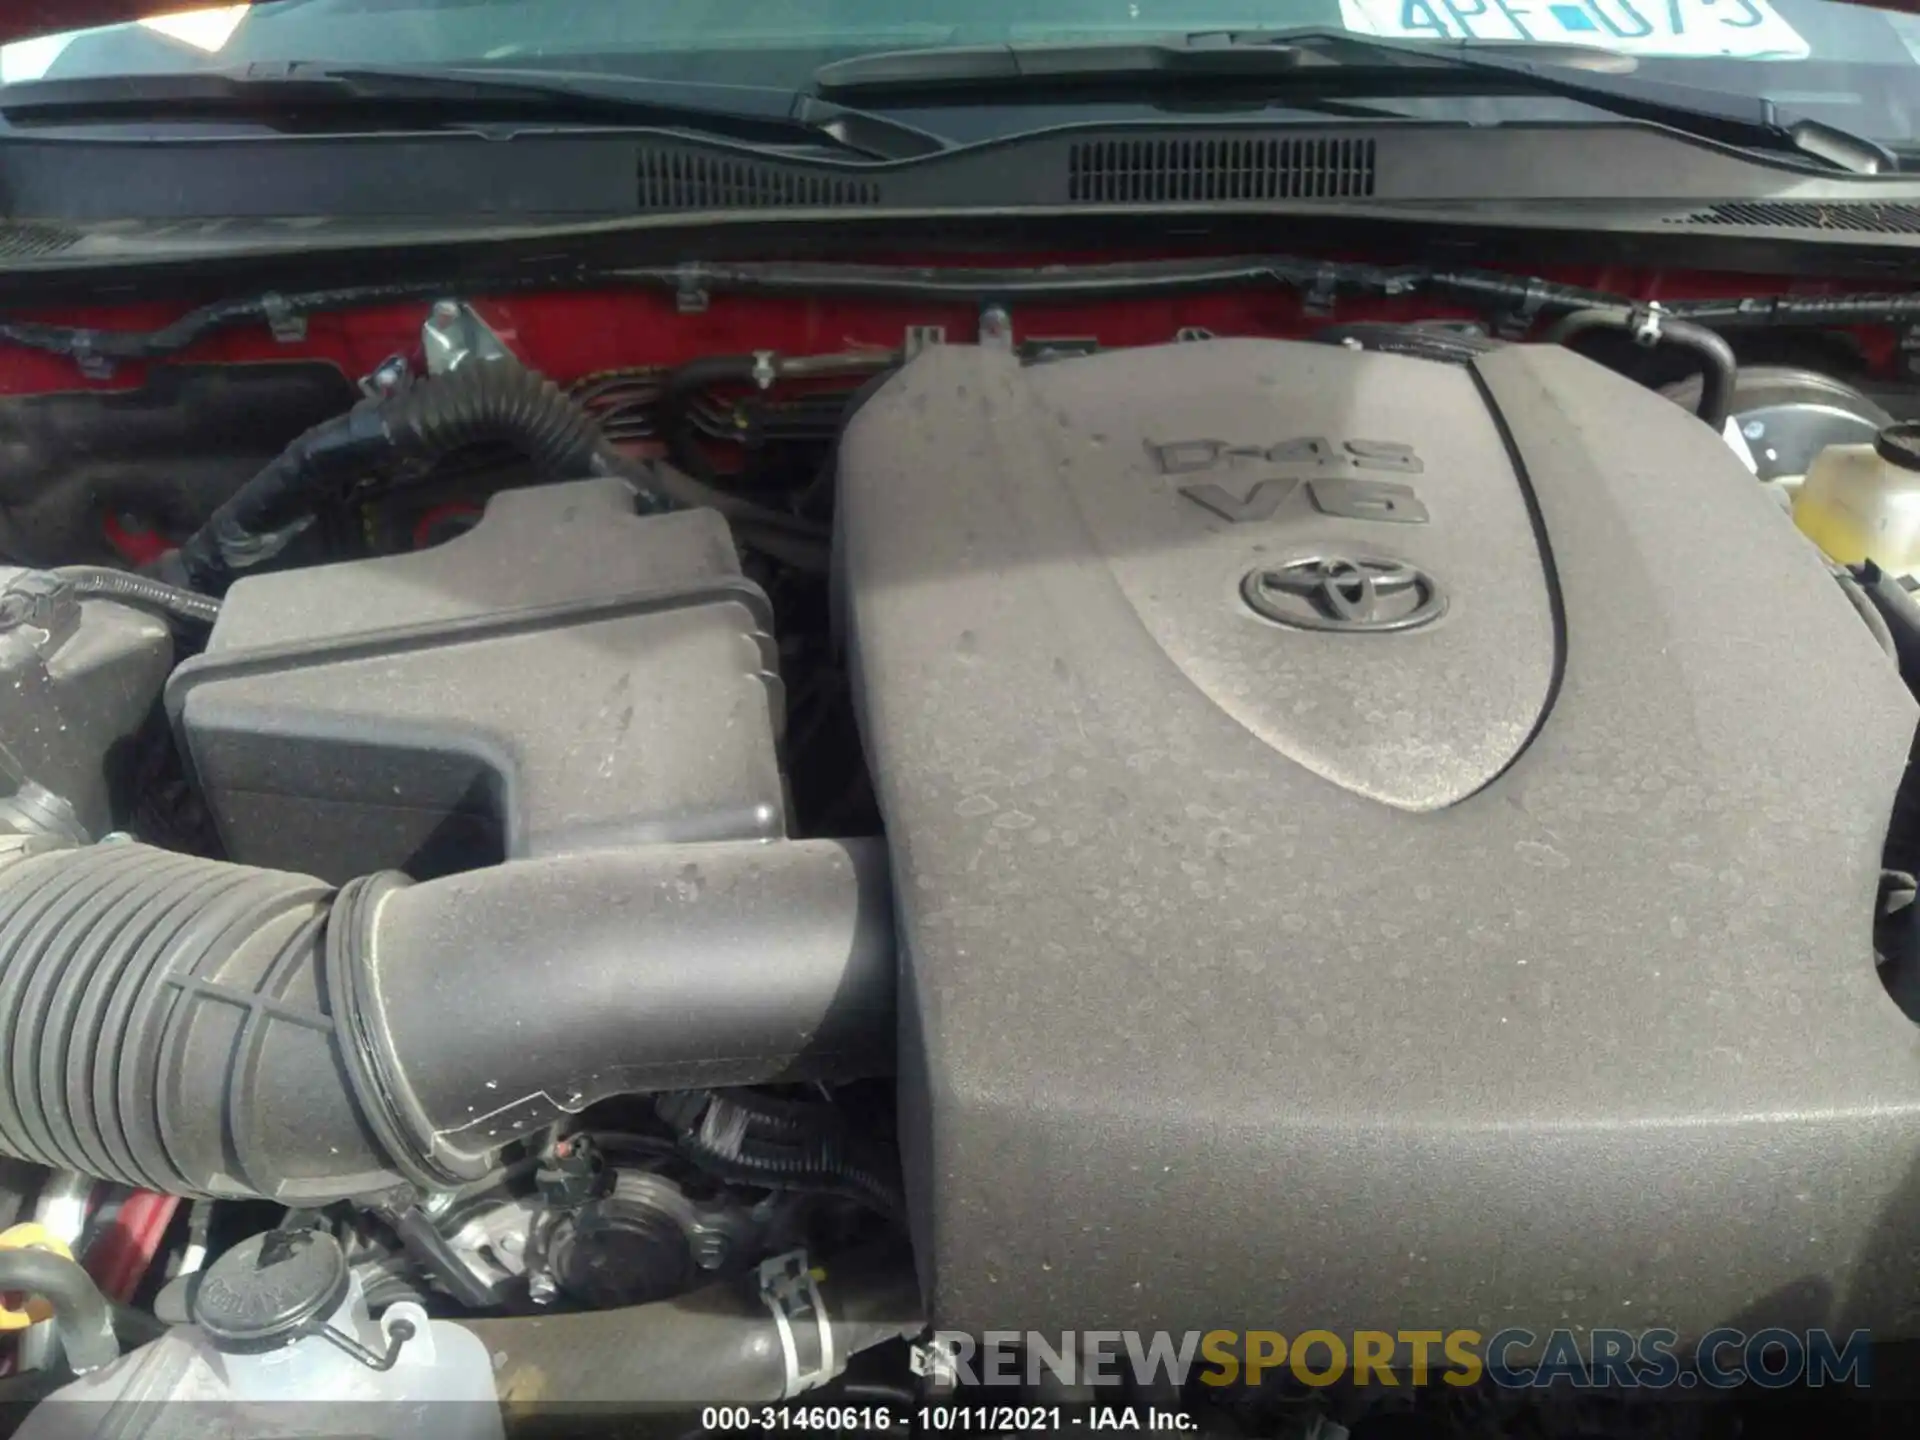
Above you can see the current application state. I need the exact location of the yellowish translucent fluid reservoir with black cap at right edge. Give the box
[1793,422,1920,574]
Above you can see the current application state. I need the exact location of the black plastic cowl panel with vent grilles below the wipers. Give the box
[11,121,1920,227]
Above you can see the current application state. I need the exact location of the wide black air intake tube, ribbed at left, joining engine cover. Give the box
[0,841,893,1206]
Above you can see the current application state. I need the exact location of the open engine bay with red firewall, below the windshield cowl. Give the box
[0,264,1920,1432]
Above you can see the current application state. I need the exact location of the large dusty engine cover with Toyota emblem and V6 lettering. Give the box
[841,340,1920,1334]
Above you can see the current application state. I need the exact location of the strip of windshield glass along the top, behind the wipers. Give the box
[11,0,1920,150]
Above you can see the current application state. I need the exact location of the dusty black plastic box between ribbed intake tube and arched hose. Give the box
[167,480,785,881]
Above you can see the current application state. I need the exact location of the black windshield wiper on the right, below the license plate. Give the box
[814,29,1899,175]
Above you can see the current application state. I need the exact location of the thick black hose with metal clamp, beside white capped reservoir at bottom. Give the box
[461,1246,925,1413]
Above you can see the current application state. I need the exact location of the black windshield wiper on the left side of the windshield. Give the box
[0,63,948,159]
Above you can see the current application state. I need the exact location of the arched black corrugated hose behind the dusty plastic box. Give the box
[179,361,664,593]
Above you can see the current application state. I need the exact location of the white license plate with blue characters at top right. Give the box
[1340,0,1809,60]
